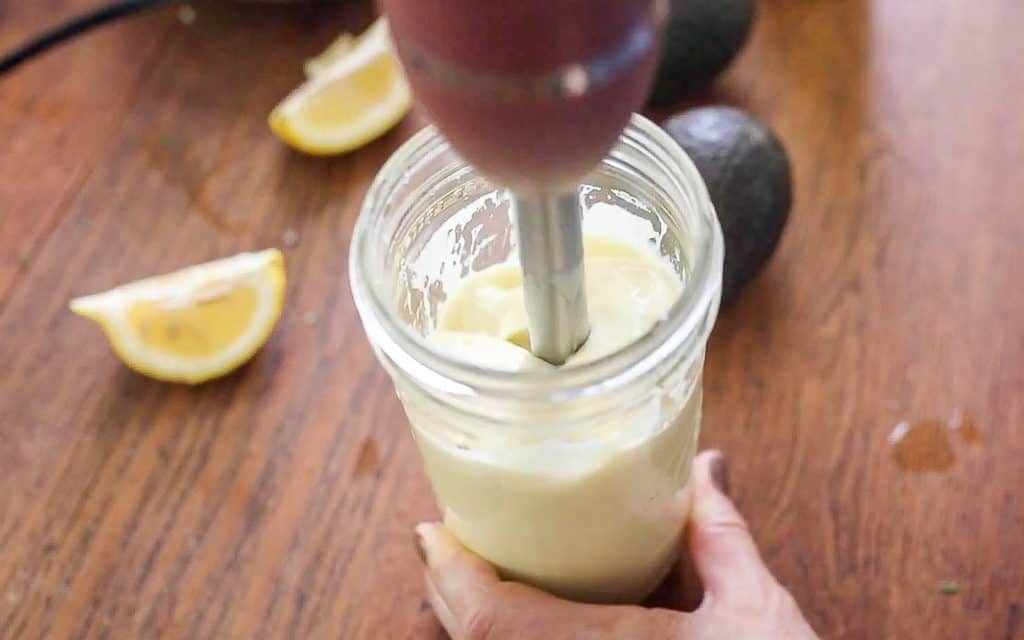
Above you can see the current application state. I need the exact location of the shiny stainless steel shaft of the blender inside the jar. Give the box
[512,189,590,365]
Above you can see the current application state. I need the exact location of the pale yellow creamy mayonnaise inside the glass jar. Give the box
[406,236,700,602]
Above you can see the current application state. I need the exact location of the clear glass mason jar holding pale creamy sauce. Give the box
[349,116,723,602]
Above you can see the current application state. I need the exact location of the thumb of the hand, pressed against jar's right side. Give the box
[689,451,776,606]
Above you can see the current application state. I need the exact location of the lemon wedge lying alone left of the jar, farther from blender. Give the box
[71,249,285,384]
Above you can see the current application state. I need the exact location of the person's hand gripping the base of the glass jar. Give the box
[416,452,817,640]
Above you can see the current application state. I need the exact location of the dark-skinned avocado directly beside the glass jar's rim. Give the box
[663,106,793,306]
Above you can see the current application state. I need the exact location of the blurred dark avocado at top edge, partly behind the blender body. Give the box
[648,0,754,106]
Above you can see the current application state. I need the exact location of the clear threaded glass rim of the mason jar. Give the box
[348,114,724,402]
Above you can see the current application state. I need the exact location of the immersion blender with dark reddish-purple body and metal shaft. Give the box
[381,0,659,365]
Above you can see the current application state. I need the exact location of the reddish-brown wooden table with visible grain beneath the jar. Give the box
[0,0,1024,640]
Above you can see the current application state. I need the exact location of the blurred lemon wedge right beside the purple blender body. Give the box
[276,18,413,156]
